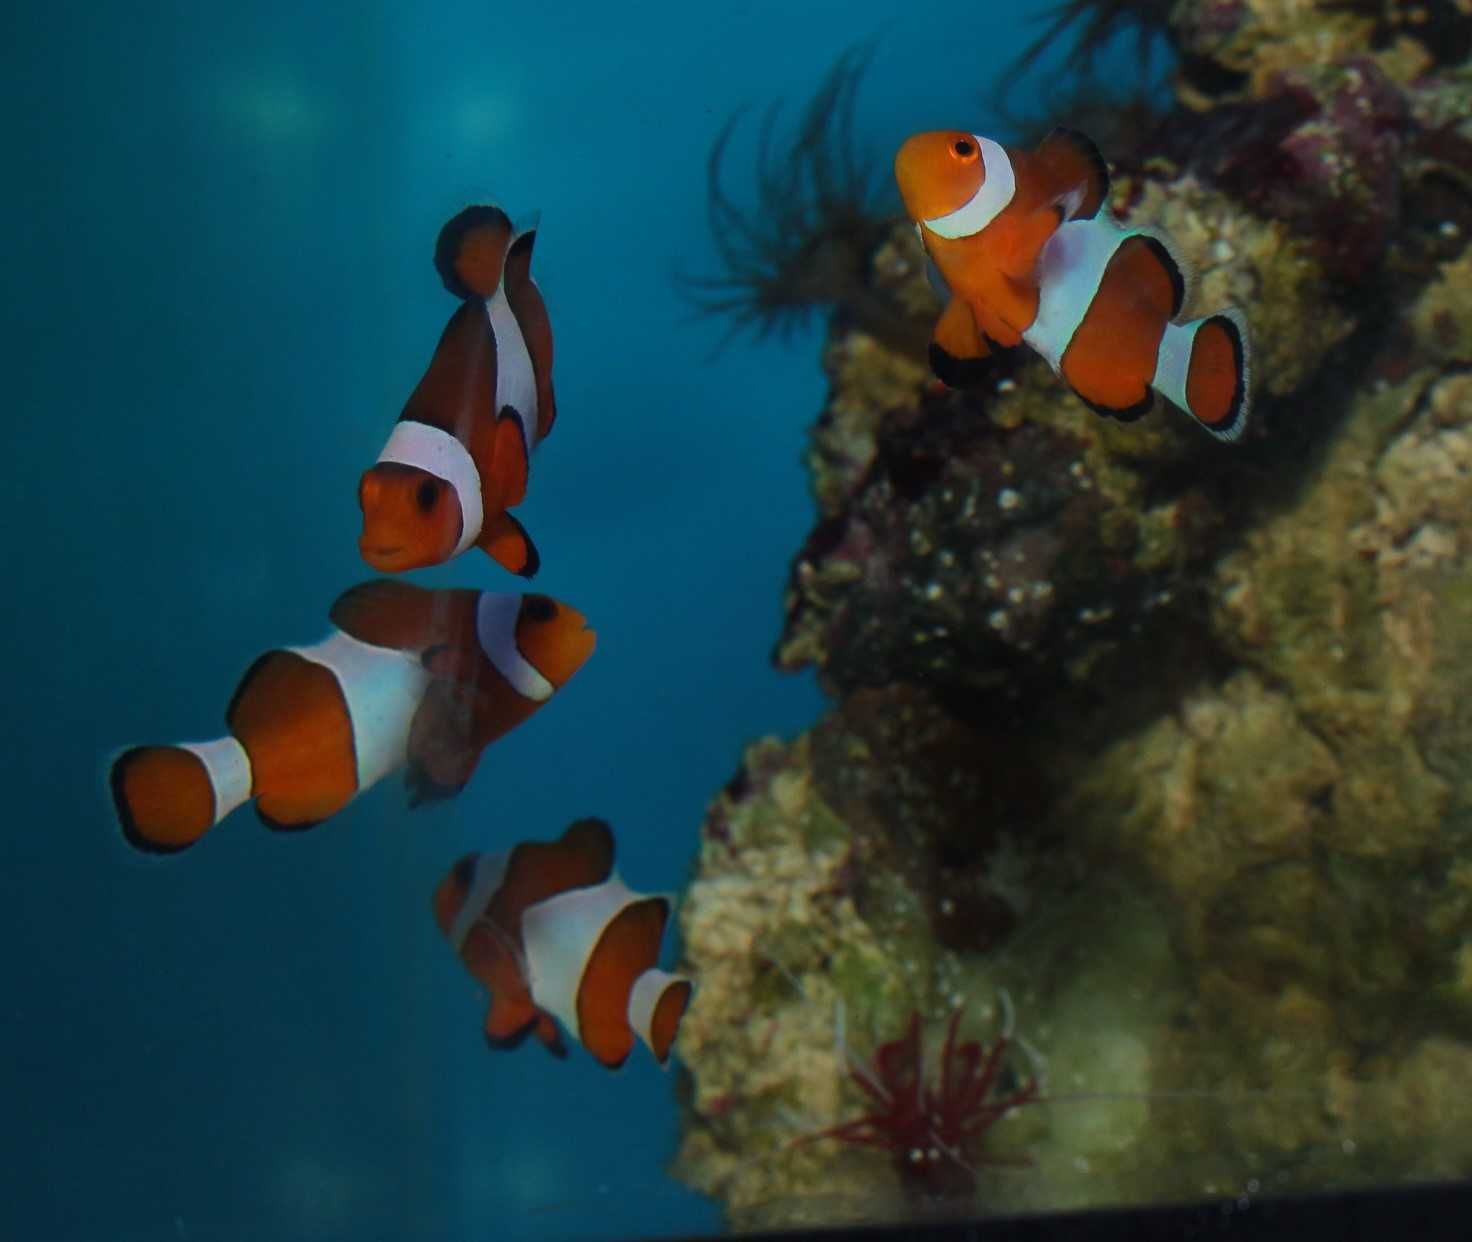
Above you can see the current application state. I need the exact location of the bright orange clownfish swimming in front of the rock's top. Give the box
[895,129,1248,440]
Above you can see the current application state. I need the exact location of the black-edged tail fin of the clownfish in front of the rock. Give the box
[1151,308,1251,441]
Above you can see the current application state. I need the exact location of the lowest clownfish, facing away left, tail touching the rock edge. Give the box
[433,820,692,1070]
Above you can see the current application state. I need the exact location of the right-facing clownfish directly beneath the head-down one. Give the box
[109,578,595,854]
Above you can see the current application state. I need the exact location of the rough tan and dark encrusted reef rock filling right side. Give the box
[676,0,1472,1226]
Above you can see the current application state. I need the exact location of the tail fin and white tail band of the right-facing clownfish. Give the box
[107,737,250,854]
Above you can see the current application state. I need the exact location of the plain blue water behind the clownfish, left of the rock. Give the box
[0,0,1159,1242]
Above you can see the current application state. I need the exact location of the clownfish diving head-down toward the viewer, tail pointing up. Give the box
[358,206,556,578]
